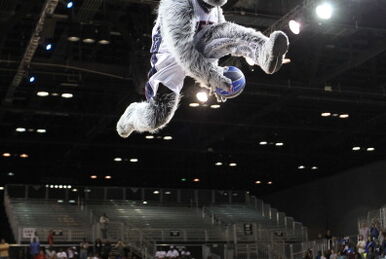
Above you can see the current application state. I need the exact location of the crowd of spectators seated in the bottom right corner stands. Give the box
[304,224,386,259]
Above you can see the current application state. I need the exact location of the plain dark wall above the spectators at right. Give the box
[261,161,386,241]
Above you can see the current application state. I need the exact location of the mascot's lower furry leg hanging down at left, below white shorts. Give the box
[117,85,180,138]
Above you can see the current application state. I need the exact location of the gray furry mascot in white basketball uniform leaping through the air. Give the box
[117,0,289,138]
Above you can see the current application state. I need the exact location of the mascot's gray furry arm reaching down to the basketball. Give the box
[158,0,230,88]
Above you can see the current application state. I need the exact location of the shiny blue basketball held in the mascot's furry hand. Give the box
[216,66,246,99]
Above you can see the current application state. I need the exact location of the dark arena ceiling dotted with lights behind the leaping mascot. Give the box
[0,0,386,194]
